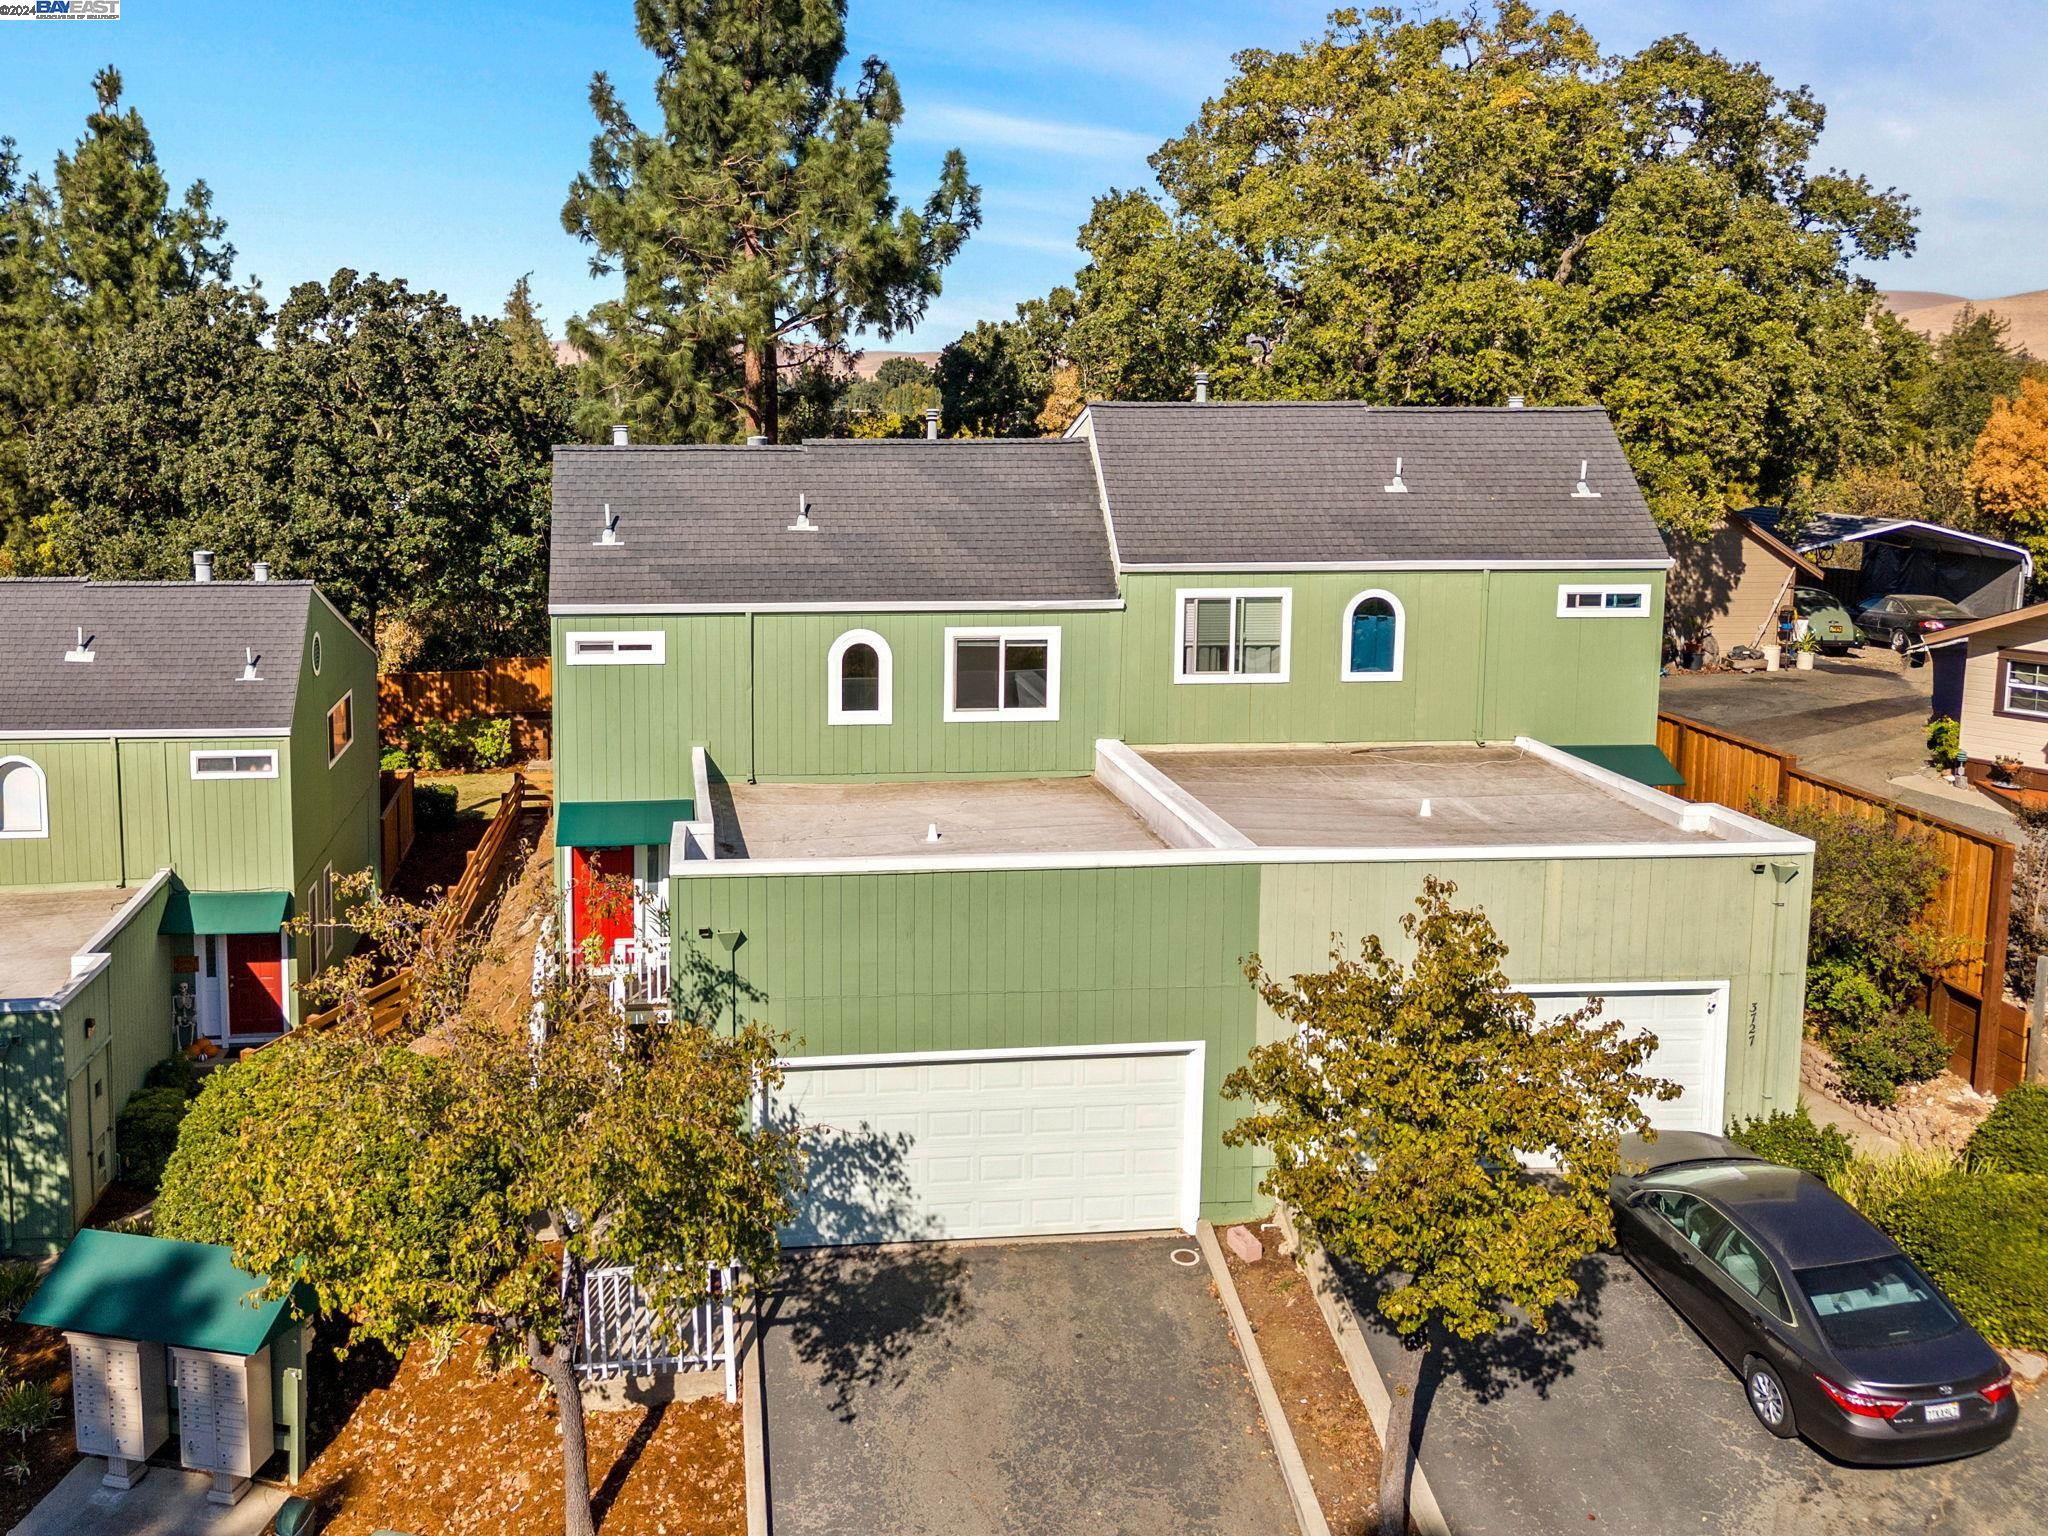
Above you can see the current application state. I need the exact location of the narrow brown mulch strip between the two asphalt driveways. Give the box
[1219,1223,1380,1536]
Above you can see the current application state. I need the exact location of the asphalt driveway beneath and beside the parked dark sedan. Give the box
[1348,1253,2048,1536]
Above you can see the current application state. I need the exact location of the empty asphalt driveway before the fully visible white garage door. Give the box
[756,1237,1296,1536]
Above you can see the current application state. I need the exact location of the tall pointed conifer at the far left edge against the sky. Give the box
[0,68,233,571]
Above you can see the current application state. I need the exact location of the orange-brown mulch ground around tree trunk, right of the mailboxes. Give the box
[299,1329,745,1536]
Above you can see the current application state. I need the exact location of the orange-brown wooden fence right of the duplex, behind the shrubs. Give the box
[1657,715,2028,1094]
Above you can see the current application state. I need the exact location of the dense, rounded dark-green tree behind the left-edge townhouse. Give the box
[33,268,569,664]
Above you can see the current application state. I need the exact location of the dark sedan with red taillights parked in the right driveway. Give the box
[1612,1130,2019,1464]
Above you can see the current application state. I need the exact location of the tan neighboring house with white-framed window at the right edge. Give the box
[1927,602,2048,788]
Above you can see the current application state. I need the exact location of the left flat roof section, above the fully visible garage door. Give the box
[717,778,1165,858]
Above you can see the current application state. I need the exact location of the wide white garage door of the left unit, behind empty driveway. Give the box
[772,1044,1202,1245]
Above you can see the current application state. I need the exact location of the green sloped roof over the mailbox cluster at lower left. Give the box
[18,1227,311,1356]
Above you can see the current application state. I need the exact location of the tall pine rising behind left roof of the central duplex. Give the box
[561,0,981,442]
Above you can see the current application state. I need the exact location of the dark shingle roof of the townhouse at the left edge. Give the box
[0,578,313,735]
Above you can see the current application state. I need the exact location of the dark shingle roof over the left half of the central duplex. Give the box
[549,438,1116,610]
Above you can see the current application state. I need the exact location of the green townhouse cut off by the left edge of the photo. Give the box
[0,553,379,1251]
